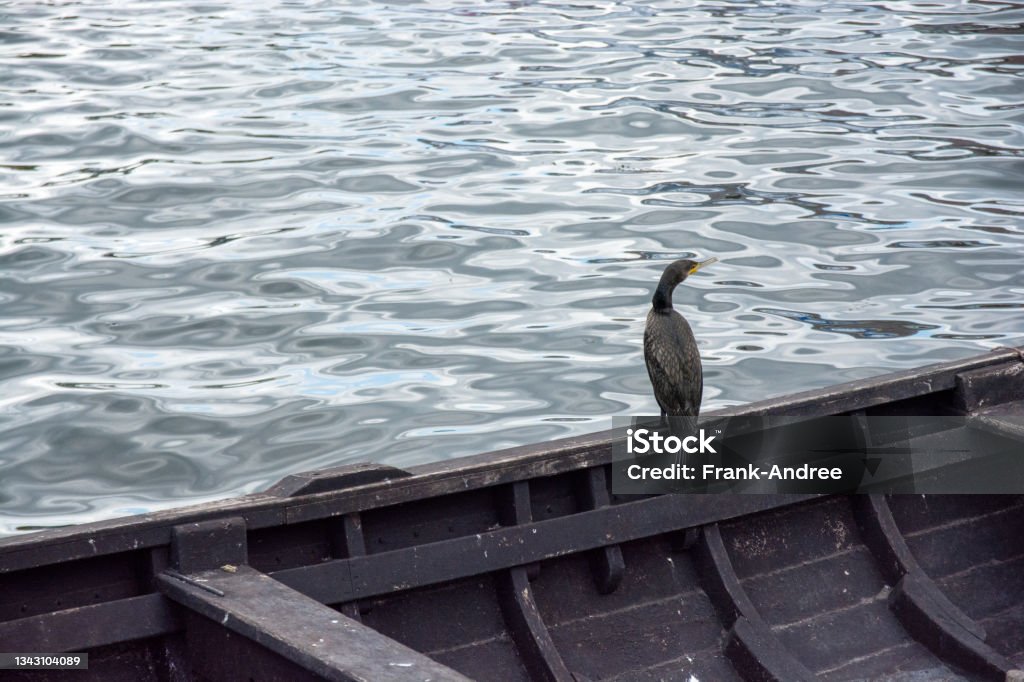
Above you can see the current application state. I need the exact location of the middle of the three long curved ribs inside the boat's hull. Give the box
[694,523,814,682]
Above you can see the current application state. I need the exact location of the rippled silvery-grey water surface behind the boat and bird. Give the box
[0,0,1024,534]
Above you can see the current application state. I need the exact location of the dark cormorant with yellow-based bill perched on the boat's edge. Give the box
[643,258,718,436]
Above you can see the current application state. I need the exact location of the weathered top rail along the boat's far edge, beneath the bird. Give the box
[0,349,1020,573]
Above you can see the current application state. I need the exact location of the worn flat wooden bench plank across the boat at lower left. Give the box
[157,566,467,682]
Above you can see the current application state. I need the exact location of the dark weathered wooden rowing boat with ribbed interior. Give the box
[0,349,1024,682]
